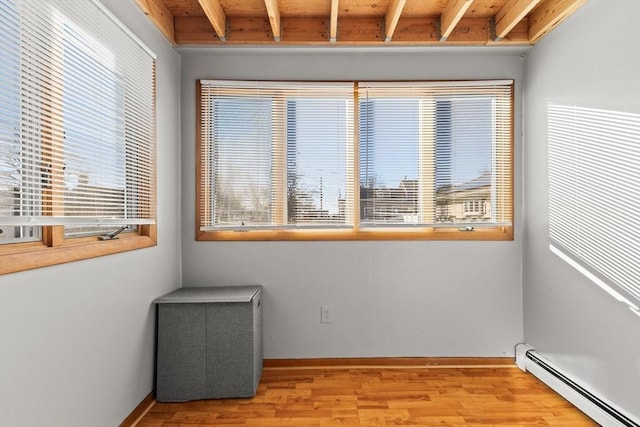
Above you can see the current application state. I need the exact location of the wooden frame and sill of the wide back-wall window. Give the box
[195,80,515,241]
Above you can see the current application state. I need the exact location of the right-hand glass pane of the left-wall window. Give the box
[62,18,126,222]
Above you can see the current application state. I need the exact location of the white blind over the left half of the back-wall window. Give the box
[199,80,354,230]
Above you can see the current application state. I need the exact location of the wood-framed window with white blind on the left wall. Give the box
[0,0,155,273]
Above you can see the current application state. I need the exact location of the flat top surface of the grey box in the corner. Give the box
[153,285,262,304]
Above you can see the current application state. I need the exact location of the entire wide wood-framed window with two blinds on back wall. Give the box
[197,80,513,240]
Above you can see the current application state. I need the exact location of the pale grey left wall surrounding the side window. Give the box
[0,0,181,427]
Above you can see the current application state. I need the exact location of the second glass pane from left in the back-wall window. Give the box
[287,99,350,224]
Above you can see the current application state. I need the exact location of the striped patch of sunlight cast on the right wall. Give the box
[548,104,640,304]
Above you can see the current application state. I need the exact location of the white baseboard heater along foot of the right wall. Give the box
[516,345,640,427]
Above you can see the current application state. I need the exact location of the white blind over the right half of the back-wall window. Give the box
[358,81,513,228]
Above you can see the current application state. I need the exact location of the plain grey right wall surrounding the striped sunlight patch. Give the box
[524,0,640,419]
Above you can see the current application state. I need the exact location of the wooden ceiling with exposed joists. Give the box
[136,0,587,46]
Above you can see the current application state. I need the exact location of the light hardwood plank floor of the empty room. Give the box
[137,359,597,427]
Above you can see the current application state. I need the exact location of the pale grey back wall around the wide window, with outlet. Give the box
[181,48,523,358]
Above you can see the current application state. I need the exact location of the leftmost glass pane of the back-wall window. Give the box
[209,96,273,226]
